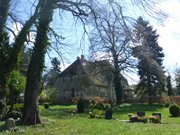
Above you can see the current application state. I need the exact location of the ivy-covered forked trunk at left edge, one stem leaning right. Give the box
[0,0,41,103]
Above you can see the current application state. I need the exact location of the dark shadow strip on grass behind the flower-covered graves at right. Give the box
[114,104,164,114]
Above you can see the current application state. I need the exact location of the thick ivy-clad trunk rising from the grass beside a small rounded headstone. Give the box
[23,0,53,125]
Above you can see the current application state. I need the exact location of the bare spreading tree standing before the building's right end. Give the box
[90,5,131,104]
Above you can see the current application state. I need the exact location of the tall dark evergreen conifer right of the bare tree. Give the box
[133,17,165,104]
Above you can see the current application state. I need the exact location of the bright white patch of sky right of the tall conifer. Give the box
[153,0,180,72]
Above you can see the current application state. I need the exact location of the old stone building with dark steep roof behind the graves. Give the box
[54,55,128,103]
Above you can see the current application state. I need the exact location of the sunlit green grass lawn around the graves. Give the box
[0,104,180,135]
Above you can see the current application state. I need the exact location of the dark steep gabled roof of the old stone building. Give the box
[59,55,128,87]
